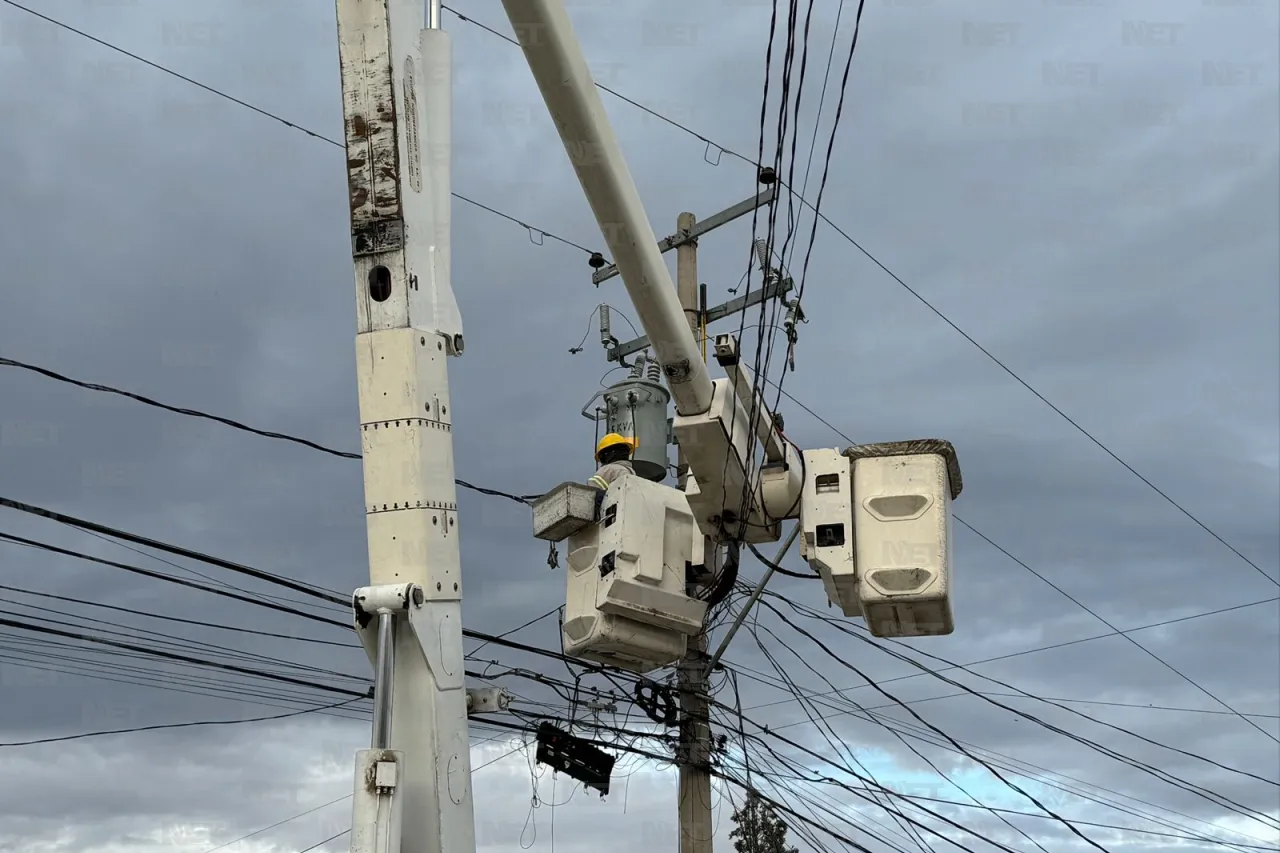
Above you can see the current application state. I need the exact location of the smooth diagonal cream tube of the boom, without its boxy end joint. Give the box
[502,0,712,416]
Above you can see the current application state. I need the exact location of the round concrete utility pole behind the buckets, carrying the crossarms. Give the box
[676,213,716,853]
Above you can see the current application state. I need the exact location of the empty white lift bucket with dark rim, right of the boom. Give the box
[800,439,963,637]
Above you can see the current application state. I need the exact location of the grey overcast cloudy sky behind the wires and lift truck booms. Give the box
[0,0,1280,853]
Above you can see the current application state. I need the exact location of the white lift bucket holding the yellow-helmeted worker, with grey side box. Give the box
[534,476,707,672]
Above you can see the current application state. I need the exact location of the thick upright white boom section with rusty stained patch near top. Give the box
[337,0,475,853]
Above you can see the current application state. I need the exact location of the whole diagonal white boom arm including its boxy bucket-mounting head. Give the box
[503,0,803,542]
